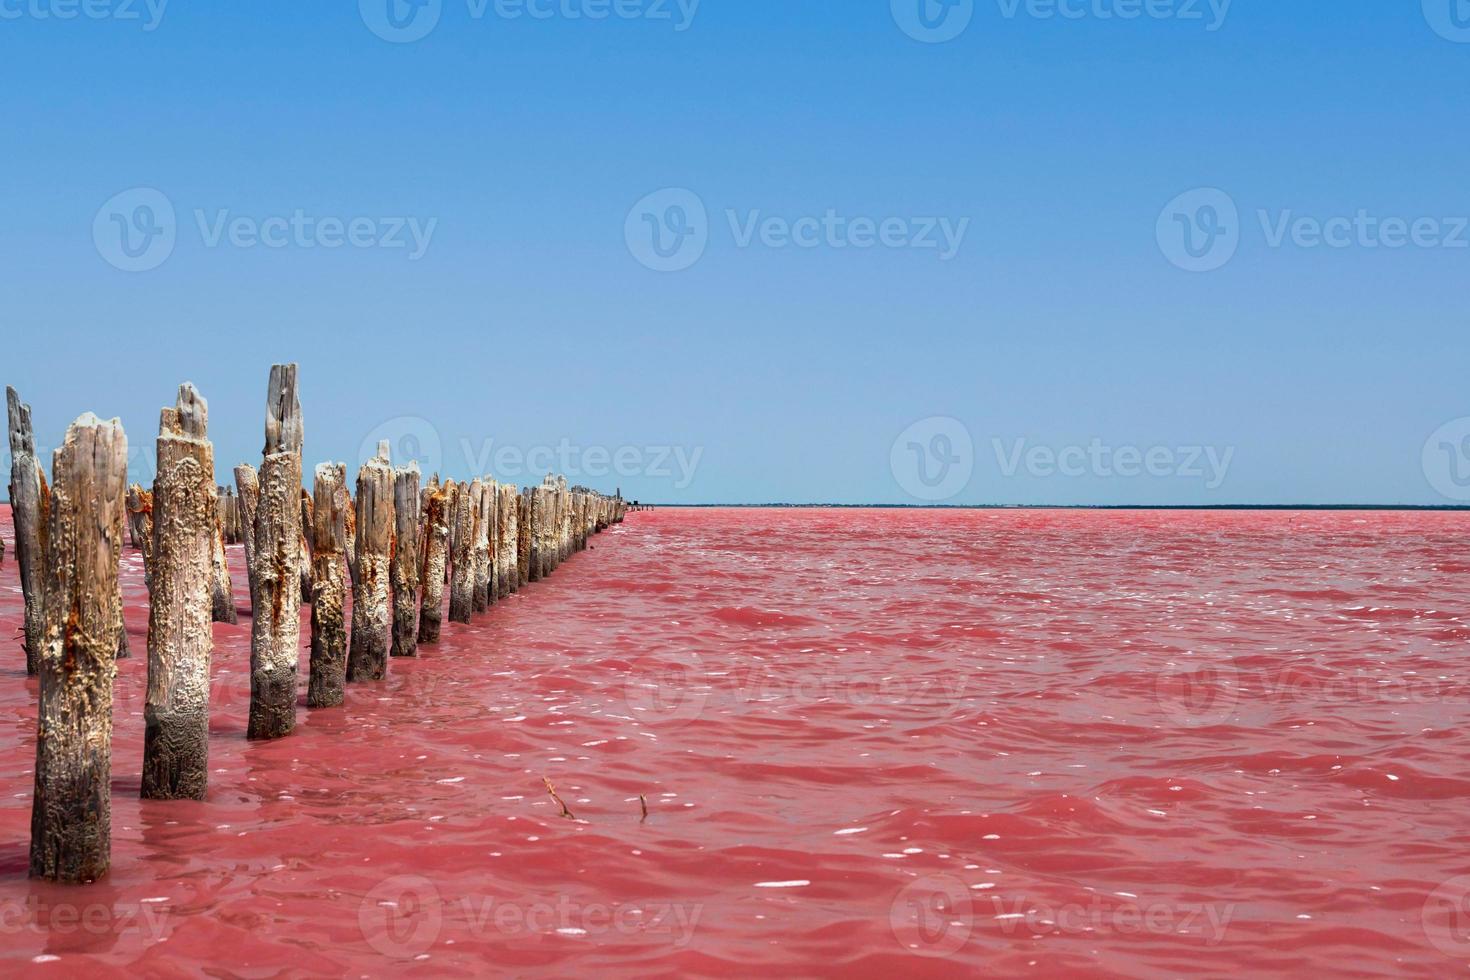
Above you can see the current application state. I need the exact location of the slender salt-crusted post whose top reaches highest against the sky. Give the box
[237,364,303,739]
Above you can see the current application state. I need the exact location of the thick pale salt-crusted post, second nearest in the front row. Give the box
[143,383,219,799]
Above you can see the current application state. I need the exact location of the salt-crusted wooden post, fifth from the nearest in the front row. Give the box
[347,441,394,682]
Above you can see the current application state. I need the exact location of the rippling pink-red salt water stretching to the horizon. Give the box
[0,510,1470,977]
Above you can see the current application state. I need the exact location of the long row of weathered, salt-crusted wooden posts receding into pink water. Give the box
[6,364,628,882]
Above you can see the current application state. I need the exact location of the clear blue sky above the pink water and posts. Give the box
[0,0,1470,504]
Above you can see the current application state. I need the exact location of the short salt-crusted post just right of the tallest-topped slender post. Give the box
[306,463,347,708]
